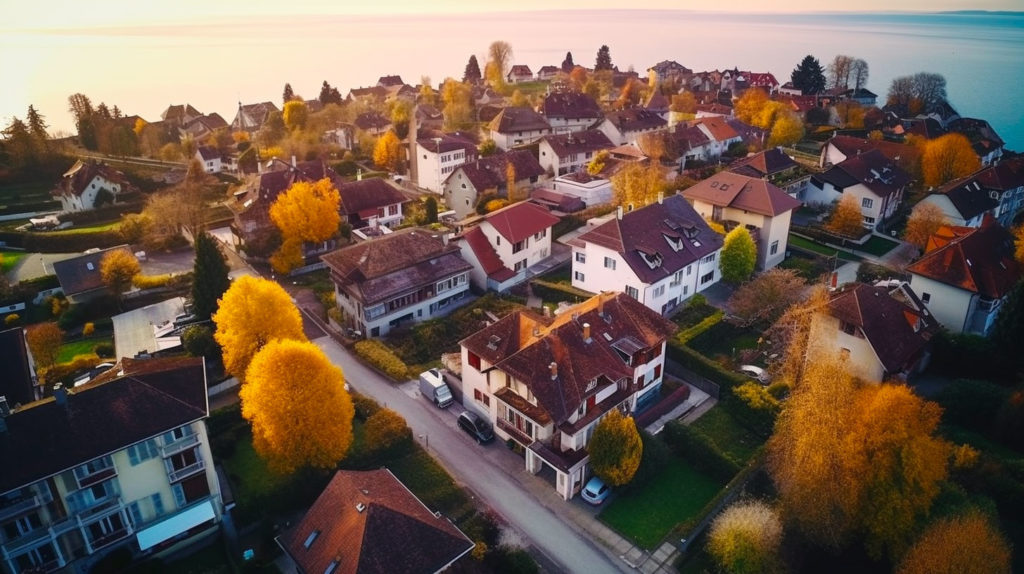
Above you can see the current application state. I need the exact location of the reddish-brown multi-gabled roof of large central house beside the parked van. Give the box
[461,293,677,427]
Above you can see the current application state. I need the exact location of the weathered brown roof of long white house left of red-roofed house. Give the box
[321,228,472,305]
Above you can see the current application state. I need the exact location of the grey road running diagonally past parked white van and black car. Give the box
[313,337,629,574]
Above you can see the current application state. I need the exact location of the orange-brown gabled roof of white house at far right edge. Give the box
[906,217,1024,299]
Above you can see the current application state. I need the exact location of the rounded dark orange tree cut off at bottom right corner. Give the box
[896,511,1012,574]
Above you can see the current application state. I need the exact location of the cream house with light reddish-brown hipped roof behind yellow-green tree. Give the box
[683,172,800,270]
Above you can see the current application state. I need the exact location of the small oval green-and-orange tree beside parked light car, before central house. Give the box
[587,408,643,486]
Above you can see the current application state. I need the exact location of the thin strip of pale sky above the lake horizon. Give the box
[0,0,1024,31]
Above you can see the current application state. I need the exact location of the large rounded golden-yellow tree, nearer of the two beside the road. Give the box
[239,340,355,474]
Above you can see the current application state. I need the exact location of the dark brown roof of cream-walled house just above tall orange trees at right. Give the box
[828,283,939,372]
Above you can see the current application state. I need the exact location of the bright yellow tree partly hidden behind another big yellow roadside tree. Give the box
[213,275,305,383]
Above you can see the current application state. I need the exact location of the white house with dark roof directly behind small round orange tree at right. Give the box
[804,149,910,229]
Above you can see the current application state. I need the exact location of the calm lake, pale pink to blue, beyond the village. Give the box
[0,10,1024,149]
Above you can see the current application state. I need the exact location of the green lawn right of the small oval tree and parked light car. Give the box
[598,458,723,549]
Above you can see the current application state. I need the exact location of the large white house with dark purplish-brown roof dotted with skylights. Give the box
[569,195,723,316]
